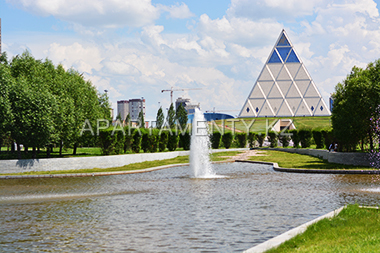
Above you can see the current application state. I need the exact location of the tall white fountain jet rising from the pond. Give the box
[190,108,216,178]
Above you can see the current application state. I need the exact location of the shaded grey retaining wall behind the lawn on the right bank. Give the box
[271,148,371,166]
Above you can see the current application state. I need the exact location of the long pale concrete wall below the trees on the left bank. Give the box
[0,149,247,174]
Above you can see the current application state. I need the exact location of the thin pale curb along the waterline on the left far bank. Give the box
[0,160,234,180]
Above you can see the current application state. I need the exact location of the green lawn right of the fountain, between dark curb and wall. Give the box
[249,150,372,170]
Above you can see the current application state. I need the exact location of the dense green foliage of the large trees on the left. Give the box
[0,51,110,157]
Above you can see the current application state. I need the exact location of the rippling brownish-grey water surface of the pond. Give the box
[0,163,380,252]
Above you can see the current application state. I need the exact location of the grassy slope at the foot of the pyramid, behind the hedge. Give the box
[213,116,331,132]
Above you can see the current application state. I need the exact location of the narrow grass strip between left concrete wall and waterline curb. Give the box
[0,151,241,176]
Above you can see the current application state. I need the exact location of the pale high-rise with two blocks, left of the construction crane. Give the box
[117,98,145,121]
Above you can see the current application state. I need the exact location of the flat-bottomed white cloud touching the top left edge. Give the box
[6,0,160,27]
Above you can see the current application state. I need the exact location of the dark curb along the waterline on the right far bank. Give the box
[235,160,380,175]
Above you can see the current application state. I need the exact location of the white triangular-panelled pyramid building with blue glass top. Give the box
[239,30,331,117]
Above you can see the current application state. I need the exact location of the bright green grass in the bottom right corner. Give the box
[267,205,380,253]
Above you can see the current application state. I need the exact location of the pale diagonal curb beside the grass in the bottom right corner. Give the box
[243,206,344,253]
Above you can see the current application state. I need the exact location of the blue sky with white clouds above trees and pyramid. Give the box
[0,0,380,121]
